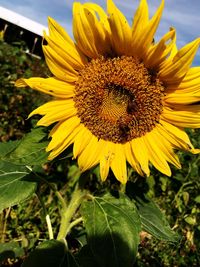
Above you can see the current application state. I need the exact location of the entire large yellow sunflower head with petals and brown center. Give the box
[16,0,200,183]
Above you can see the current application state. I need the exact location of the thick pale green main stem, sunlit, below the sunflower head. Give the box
[57,187,87,240]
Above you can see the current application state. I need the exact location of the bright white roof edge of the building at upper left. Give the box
[0,6,48,36]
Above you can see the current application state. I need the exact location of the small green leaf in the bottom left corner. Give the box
[0,242,24,263]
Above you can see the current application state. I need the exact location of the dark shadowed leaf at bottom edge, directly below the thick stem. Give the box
[22,240,79,267]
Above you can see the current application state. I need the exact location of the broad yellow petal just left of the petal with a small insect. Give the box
[78,135,102,172]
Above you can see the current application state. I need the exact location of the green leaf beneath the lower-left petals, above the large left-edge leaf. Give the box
[4,128,48,166]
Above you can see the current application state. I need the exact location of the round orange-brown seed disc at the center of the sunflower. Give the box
[74,56,164,143]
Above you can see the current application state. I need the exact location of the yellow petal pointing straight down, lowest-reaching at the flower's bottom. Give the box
[111,143,127,184]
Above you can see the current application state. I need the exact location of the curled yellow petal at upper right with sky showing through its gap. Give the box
[144,28,176,69]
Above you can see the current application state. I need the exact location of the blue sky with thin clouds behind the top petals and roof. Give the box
[0,0,200,65]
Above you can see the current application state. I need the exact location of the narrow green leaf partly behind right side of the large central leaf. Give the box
[136,197,179,242]
